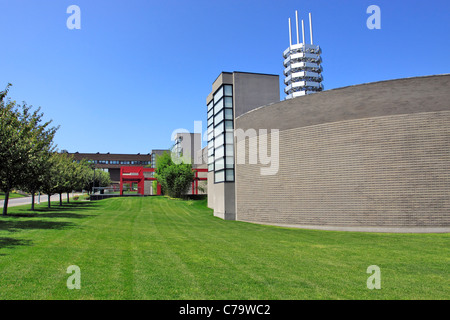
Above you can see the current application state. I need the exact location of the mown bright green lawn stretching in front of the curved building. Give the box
[0,197,450,299]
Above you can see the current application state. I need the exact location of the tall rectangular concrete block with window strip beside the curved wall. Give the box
[206,72,280,219]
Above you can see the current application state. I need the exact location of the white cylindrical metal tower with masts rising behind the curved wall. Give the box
[283,11,323,99]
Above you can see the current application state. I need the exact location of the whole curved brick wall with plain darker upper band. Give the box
[236,75,450,232]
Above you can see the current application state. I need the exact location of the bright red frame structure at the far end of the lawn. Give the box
[120,167,208,195]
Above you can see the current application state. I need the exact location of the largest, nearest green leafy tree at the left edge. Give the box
[0,84,58,215]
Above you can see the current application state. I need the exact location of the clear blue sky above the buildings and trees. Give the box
[0,0,450,153]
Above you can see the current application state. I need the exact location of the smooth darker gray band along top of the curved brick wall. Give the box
[236,75,450,130]
